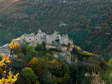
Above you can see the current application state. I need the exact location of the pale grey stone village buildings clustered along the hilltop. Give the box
[2,30,73,62]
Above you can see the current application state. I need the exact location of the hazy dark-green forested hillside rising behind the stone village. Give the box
[0,0,112,53]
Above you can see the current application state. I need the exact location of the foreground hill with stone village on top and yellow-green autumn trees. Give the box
[0,31,109,84]
